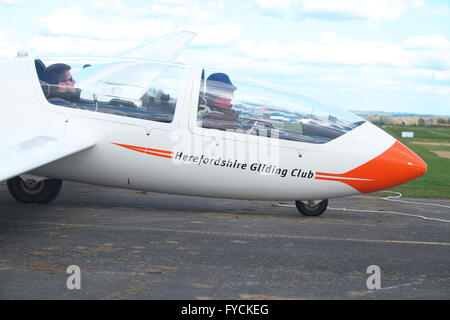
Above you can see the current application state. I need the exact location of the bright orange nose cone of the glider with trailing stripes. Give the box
[316,141,427,193]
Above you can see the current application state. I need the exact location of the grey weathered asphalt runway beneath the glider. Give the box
[0,182,450,300]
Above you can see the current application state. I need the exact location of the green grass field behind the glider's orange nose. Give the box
[374,126,450,199]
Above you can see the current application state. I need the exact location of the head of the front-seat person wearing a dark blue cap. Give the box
[206,73,237,109]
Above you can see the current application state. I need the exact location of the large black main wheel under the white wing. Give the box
[6,177,62,203]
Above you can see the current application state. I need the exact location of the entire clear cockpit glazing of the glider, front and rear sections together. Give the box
[35,58,365,144]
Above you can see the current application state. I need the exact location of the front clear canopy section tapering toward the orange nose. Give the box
[197,70,365,143]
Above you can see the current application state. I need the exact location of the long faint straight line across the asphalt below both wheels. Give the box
[7,221,450,246]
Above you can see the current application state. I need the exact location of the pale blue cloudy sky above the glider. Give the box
[0,0,450,116]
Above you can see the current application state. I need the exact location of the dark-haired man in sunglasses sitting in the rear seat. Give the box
[44,63,81,105]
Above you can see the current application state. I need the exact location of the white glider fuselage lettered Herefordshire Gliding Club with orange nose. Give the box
[0,58,426,200]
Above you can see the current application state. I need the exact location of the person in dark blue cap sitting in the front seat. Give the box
[203,73,239,122]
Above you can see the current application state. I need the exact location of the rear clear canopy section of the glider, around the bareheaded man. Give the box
[35,59,184,123]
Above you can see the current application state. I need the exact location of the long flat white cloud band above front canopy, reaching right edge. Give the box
[236,32,450,69]
